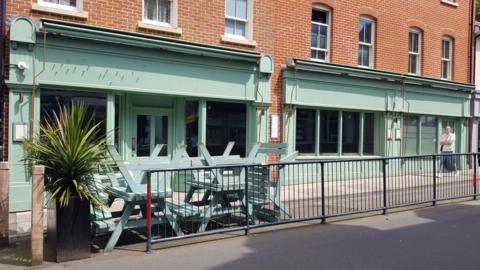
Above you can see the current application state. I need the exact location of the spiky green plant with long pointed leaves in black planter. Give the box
[23,102,106,207]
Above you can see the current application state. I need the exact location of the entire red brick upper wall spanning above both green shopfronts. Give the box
[6,0,470,148]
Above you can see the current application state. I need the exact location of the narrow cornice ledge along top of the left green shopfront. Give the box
[39,19,261,62]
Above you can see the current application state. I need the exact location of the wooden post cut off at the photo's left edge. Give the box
[0,162,9,246]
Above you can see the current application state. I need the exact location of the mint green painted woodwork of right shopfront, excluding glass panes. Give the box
[283,59,473,159]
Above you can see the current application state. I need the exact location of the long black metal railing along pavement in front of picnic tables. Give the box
[146,153,479,250]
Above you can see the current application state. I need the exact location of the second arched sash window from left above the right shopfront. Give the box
[358,17,375,68]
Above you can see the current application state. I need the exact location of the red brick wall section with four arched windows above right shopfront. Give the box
[272,0,470,142]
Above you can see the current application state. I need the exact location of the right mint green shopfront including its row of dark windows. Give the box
[283,59,474,159]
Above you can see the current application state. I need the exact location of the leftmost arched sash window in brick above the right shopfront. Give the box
[310,7,330,61]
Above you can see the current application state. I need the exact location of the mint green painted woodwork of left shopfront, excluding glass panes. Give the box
[7,17,273,212]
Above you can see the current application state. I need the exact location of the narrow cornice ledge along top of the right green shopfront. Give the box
[288,58,475,93]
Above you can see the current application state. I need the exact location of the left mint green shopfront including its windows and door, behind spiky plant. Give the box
[7,17,273,212]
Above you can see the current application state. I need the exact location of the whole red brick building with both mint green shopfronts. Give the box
[3,0,474,211]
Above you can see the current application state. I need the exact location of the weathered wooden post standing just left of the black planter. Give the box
[30,166,45,265]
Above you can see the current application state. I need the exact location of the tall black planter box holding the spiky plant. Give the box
[46,198,91,262]
